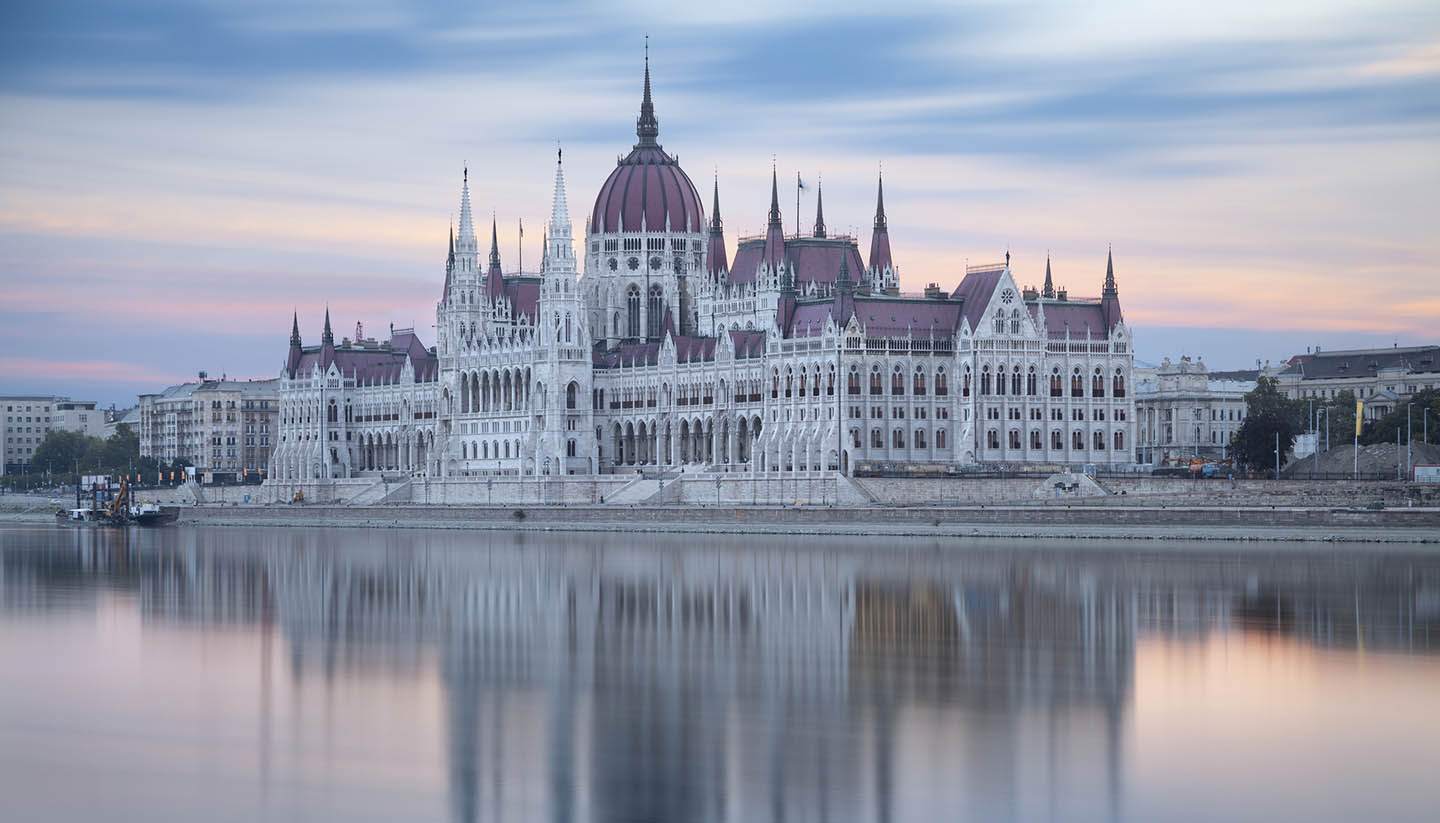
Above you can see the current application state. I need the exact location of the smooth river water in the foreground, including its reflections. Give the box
[0,524,1440,823]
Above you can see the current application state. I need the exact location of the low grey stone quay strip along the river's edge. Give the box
[11,505,1440,547]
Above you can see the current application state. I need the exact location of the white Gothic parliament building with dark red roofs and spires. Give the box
[269,62,1135,482]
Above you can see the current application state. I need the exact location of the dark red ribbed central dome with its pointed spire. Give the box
[590,59,706,232]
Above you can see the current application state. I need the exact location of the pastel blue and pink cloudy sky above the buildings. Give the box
[0,0,1440,407]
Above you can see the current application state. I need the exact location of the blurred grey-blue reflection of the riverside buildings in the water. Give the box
[0,529,1440,820]
